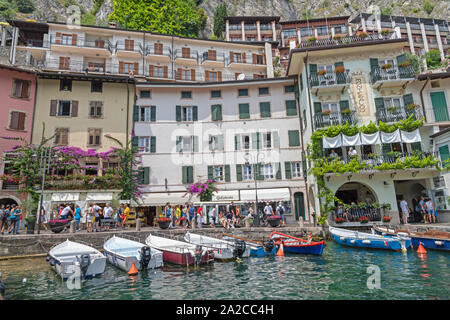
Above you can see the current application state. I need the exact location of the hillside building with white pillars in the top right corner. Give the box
[350,13,450,60]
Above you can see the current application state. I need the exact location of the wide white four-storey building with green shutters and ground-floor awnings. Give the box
[133,78,312,222]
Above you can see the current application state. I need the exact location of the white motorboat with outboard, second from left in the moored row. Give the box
[103,235,163,272]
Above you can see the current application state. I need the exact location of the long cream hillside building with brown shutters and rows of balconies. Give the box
[10,21,273,82]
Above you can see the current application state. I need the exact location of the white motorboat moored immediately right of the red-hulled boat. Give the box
[184,232,250,260]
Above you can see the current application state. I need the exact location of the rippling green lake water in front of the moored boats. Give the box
[0,241,450,300]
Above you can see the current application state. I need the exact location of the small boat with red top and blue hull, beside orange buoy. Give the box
[270,231,325,255]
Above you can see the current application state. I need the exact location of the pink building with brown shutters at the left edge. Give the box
[0,64,36,204]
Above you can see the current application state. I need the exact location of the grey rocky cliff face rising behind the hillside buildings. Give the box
[4,0,450,36]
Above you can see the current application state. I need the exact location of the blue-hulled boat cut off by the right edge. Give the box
[372,226,450,251]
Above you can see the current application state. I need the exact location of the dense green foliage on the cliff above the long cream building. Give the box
[109,0,207,37]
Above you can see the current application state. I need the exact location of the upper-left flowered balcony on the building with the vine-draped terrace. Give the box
[309,70,352,95]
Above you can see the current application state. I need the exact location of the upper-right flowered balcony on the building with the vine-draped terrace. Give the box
[370,66,415,90]
